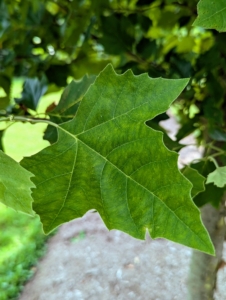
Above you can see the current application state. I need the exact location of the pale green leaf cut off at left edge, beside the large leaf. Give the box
[0,151,35,215]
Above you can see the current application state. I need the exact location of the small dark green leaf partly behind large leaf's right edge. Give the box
[181,166,206,198]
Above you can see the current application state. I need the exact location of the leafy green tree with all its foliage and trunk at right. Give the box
[0,0,226,299]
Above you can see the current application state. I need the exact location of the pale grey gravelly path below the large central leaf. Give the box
[20,213,191,300]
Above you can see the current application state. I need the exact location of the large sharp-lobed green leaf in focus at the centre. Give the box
[22,66,214,254]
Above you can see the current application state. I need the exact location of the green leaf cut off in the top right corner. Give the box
[193,0,226,32]
